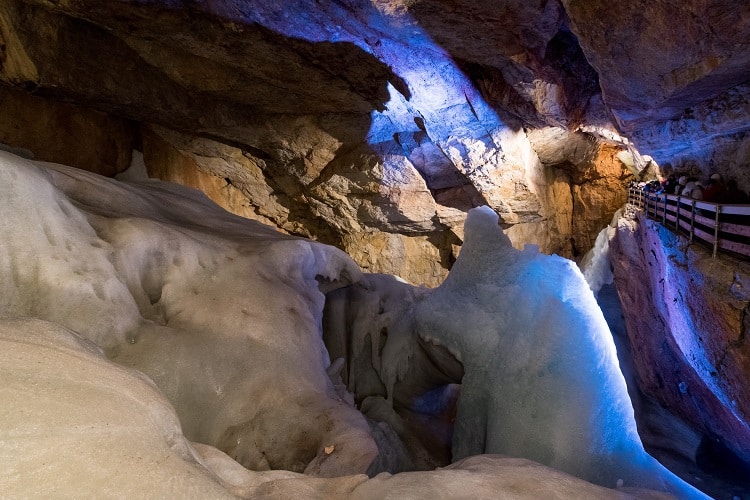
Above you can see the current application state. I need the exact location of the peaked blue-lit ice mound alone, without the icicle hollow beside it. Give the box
[415,207,701,498]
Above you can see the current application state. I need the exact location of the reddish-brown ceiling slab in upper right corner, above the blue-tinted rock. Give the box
[562,0,750,131]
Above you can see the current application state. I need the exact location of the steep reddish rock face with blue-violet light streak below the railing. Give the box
[610,214,750,462]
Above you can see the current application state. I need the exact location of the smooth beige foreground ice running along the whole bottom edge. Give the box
[0,318,648,500]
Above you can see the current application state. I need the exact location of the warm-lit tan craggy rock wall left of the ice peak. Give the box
[143,126,449,286]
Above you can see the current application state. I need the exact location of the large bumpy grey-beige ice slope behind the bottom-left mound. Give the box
[0,152,377,476]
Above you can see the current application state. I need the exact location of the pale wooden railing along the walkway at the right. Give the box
[628,187,750,258]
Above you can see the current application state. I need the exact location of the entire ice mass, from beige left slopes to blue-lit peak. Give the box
[0,151,708,499]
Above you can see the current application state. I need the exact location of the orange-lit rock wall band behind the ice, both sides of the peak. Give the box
[120,119,630,286]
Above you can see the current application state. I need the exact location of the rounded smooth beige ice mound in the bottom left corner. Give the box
[0,319,231,499]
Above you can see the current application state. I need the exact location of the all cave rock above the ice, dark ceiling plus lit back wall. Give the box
[0,0,750,278]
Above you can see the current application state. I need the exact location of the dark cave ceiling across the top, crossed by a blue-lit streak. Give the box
[0,0,750,162]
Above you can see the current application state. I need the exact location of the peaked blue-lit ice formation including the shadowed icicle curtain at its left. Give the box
[327,207,703,498]
